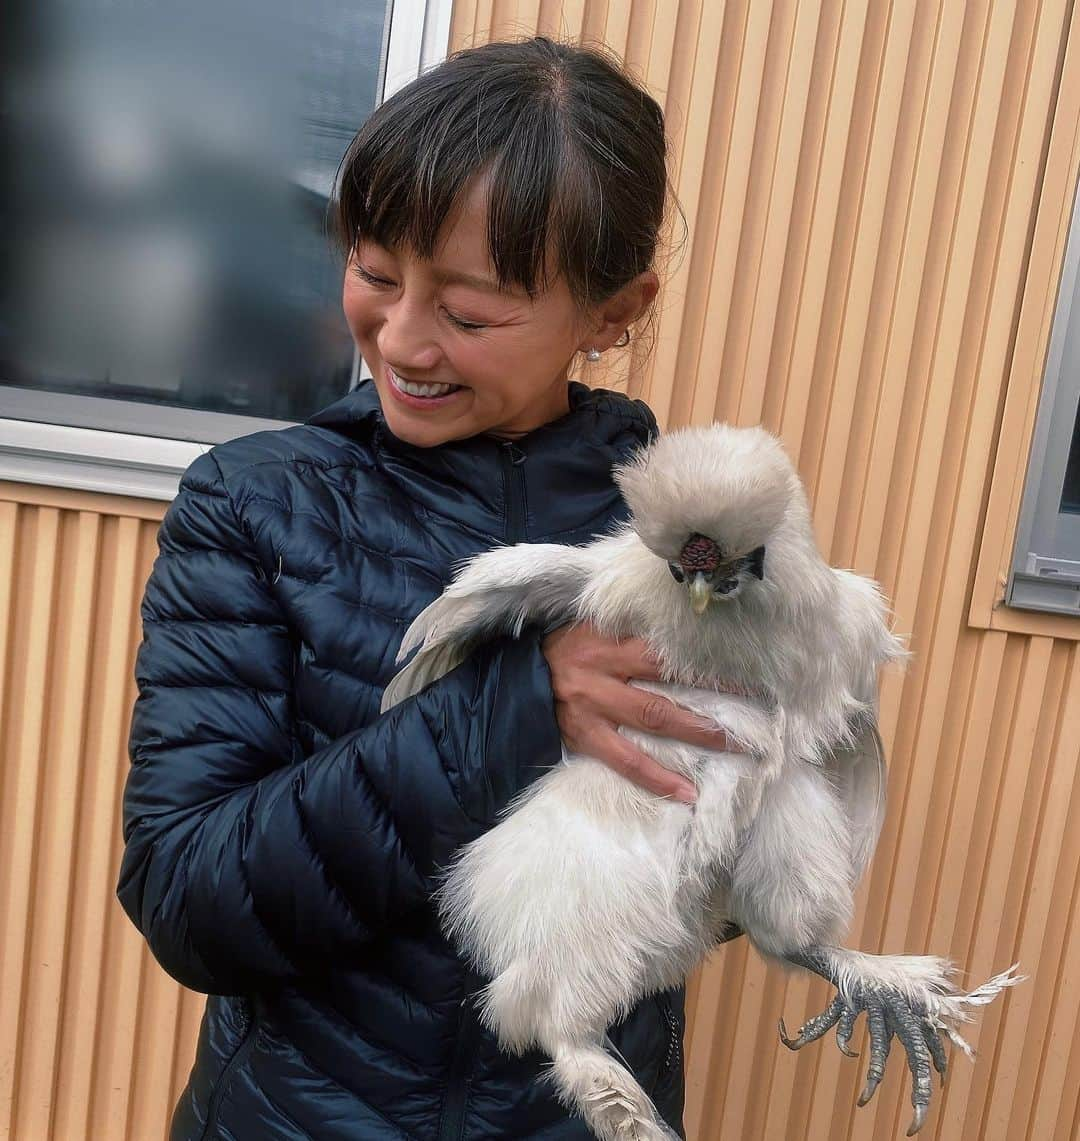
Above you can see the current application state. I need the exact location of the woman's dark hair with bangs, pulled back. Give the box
[331,35,667,319]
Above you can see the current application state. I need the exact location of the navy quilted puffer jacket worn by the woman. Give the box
[117,382,683,1141]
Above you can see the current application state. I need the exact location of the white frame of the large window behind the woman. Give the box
[0,0,453,500]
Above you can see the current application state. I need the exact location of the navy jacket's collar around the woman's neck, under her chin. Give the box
[306,380,657,542]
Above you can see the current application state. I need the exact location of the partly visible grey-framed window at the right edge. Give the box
[1006,172,1080,615]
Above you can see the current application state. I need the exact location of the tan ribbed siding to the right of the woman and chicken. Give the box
[450,0,1080,1141]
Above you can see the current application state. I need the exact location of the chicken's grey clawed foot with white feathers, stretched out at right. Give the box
[780,947,1025,1136]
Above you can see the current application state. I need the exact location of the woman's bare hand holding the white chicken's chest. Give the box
[541,623,742,804]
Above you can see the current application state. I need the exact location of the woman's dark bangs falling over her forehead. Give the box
[332,71,602,308]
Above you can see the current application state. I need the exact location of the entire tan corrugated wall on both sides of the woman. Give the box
[0,0,1080,1141]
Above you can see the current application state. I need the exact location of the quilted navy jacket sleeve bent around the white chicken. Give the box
[117,454,560,994]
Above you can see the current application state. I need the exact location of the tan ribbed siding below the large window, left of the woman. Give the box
[0,495,202,1141]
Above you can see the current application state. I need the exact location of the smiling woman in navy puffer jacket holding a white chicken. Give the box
[119,39,743,1141]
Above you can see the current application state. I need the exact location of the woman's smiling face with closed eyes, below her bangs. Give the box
[342,180,624,447]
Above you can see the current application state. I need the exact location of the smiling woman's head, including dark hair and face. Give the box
[335,35,667,446]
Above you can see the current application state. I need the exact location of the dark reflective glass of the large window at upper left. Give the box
[0,0,390,420]
